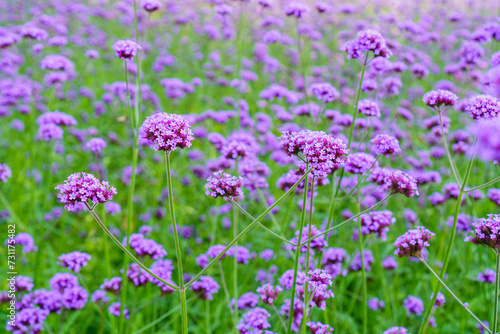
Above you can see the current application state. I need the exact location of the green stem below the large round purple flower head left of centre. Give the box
[165,152,188,334]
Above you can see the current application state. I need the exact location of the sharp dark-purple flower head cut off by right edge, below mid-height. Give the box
[465,214,500,253]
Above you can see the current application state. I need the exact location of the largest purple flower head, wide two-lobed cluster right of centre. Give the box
[279,130,349,177]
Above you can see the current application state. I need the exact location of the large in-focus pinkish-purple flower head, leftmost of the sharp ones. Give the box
[55,173,116,211]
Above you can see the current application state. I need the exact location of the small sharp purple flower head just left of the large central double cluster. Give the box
[205,171,243,200]
